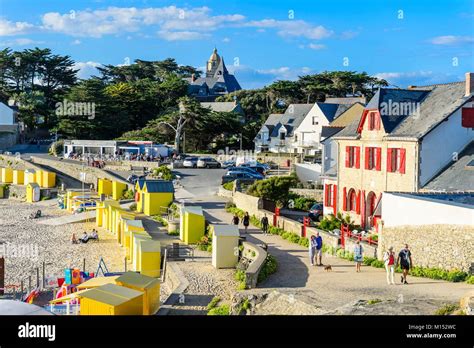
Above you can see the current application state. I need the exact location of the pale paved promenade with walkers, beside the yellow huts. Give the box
[171,170,473,314]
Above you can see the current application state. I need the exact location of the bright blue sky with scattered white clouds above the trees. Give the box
[0,0,474,88]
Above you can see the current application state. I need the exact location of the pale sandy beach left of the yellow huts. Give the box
[0,200,125,286]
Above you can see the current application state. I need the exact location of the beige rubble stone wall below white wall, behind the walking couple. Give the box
[378,225,474,272]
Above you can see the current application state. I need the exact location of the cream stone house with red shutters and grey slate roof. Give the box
[324,74,474,229]
